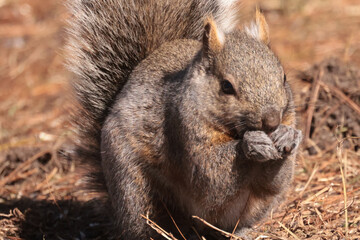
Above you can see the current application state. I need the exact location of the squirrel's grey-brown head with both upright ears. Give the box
[194,11,294,136]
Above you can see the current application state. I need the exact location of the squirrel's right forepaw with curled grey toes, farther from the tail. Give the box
[270,125,302,157]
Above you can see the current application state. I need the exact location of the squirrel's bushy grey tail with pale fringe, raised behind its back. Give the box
[68,0,239,191]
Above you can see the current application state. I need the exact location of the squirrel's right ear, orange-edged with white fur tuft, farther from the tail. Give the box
[245,8,270,45]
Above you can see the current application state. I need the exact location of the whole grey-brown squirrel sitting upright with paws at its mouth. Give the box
[68,0,302,240]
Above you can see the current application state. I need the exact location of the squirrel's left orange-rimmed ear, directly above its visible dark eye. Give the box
[203,17,225,54]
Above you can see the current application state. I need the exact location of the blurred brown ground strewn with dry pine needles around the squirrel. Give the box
[0,0,360,239]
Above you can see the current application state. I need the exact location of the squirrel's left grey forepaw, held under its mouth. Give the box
[241,131,281,162]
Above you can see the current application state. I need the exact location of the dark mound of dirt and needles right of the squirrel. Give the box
[299,58,360,155]
